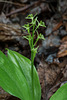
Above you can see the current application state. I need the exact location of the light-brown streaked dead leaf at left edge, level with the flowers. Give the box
[0,23,21,41]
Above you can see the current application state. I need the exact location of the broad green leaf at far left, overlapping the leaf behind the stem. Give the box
[0,51,31,100]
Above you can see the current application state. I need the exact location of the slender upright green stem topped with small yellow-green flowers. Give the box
[23,14,45,100]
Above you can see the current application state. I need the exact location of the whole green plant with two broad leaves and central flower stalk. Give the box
[0,14,45,100]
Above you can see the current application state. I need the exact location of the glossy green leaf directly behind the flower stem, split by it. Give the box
[8,50,41,100]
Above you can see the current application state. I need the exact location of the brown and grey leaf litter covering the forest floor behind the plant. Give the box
[0,0,67,100]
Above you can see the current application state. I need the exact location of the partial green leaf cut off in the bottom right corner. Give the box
[50,83,67,100]
